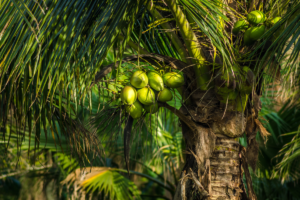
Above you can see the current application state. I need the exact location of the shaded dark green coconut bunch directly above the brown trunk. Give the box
[215,66,254,111]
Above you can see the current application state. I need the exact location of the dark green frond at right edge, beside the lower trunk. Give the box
[258,101,300,181]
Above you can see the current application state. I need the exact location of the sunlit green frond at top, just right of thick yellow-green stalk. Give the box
[179,0,236,69]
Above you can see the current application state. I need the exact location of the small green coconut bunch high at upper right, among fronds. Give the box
[232,10,281,46]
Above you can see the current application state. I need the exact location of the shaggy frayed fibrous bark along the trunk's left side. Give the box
[174,122,216,200]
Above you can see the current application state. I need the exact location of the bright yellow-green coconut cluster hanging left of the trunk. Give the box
[120,70,184,119]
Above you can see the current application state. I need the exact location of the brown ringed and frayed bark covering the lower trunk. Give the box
[174,122,243,200]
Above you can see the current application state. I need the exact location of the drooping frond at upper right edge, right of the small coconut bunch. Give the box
[250,0,300,91]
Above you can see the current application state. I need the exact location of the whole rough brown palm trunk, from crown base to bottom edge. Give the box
[174,91,256,200]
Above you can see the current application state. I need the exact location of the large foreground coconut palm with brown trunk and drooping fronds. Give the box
[0,0,300,199]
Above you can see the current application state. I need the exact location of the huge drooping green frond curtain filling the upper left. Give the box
[0,0,147,158]
